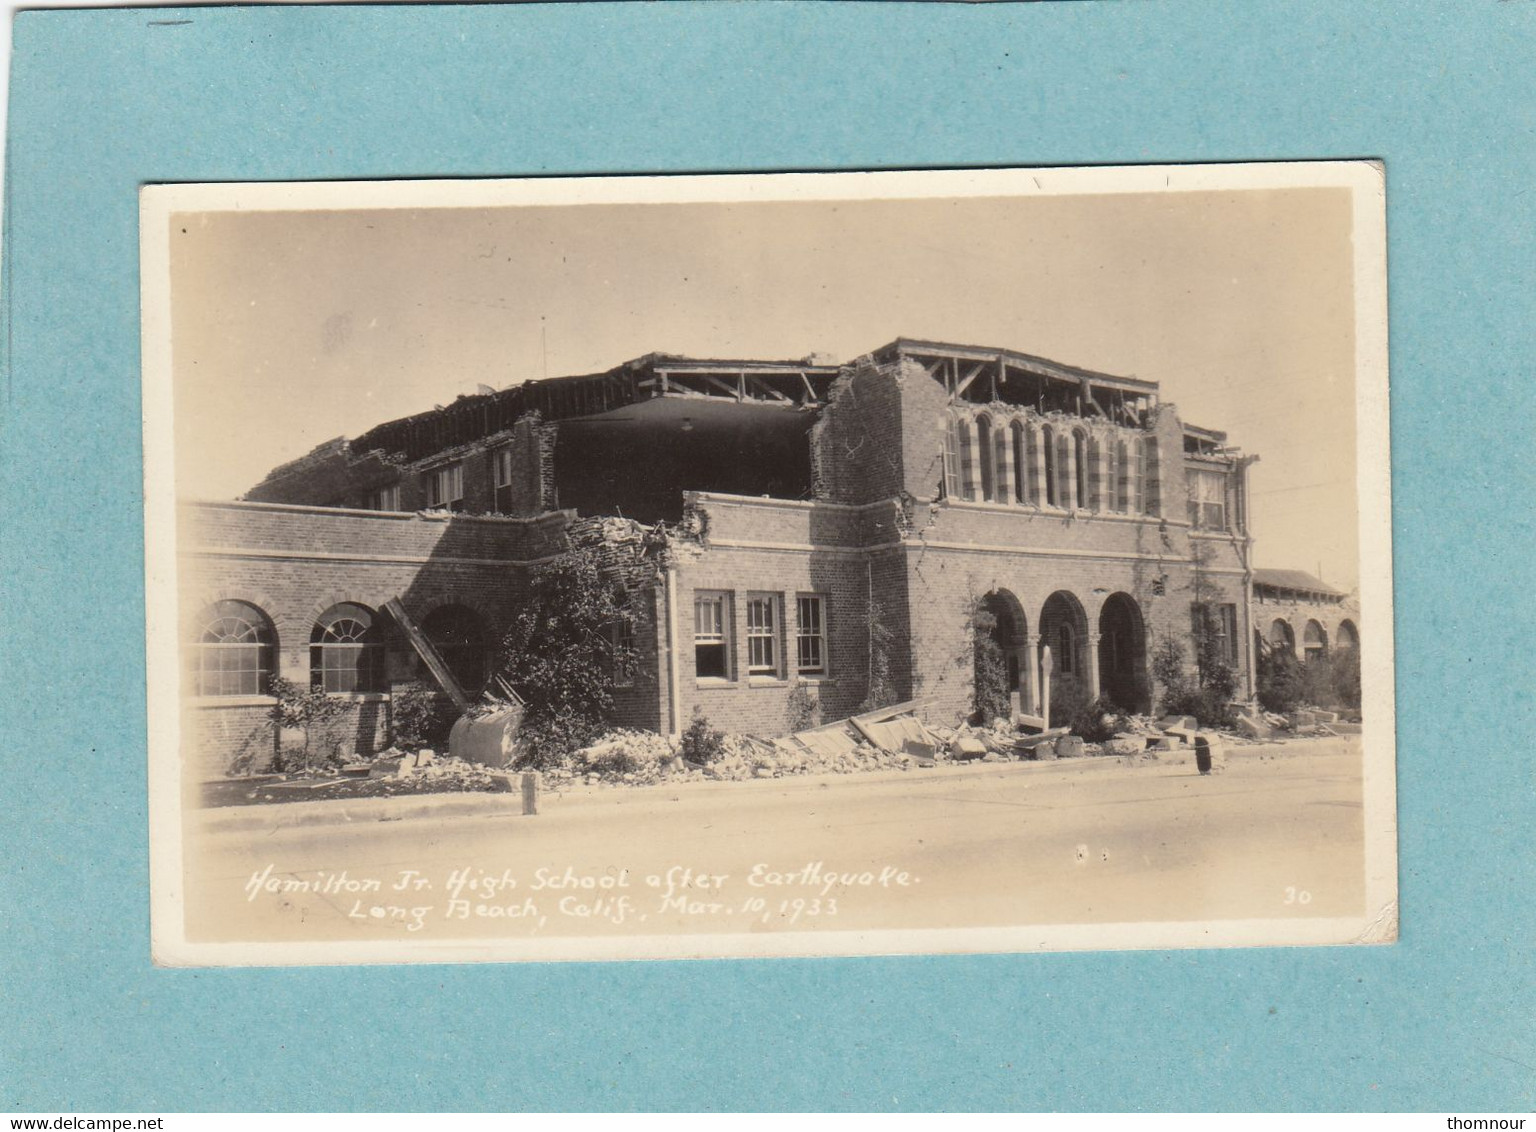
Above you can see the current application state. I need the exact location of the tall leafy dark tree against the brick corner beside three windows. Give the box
[499,547,636,766]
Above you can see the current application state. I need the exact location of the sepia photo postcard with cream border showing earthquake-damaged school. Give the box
[141,163,1398,965]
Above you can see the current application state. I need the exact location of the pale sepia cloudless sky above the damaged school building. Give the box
[170,187,1359,590]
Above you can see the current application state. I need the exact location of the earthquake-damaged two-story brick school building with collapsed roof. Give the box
[178,339,1284,774]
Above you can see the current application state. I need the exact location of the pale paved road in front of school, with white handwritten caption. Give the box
[187,739,1364,940]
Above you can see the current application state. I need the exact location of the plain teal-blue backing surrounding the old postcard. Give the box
[0,0,1536,1112]
